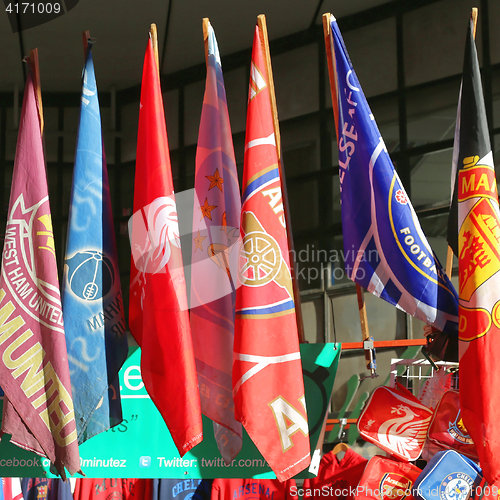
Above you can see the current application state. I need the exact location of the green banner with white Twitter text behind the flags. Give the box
[0,344,340,479]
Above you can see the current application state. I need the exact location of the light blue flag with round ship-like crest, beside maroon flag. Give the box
[62,45,128,443]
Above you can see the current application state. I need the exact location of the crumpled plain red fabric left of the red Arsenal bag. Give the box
[303,449,368,500]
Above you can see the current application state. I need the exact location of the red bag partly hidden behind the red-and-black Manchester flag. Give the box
[428,390,479,460]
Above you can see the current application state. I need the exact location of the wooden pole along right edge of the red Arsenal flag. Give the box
[257,14,306,343]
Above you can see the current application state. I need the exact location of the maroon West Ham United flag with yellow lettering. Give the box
[0,59,80,478]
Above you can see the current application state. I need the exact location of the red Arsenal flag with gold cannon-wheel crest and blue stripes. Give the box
[233,26,310,481]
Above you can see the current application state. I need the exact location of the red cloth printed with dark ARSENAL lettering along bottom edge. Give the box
[210,479,299,500]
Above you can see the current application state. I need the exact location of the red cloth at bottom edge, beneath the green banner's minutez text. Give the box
[73,478,151,500]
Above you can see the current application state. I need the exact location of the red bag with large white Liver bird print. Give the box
[358,384,432,462]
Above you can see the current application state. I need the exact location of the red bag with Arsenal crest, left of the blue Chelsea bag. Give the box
[355,455,422,500]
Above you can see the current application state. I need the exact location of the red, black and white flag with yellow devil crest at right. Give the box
[455,12,500,488]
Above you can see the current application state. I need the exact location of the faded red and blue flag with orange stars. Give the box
[190,19,242,463]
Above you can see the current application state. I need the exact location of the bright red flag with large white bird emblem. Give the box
[129,40,203,456]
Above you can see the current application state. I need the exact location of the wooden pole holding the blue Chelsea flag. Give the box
[323,13,375,375]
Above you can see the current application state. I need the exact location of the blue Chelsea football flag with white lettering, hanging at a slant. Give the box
[325,14,458,336]
